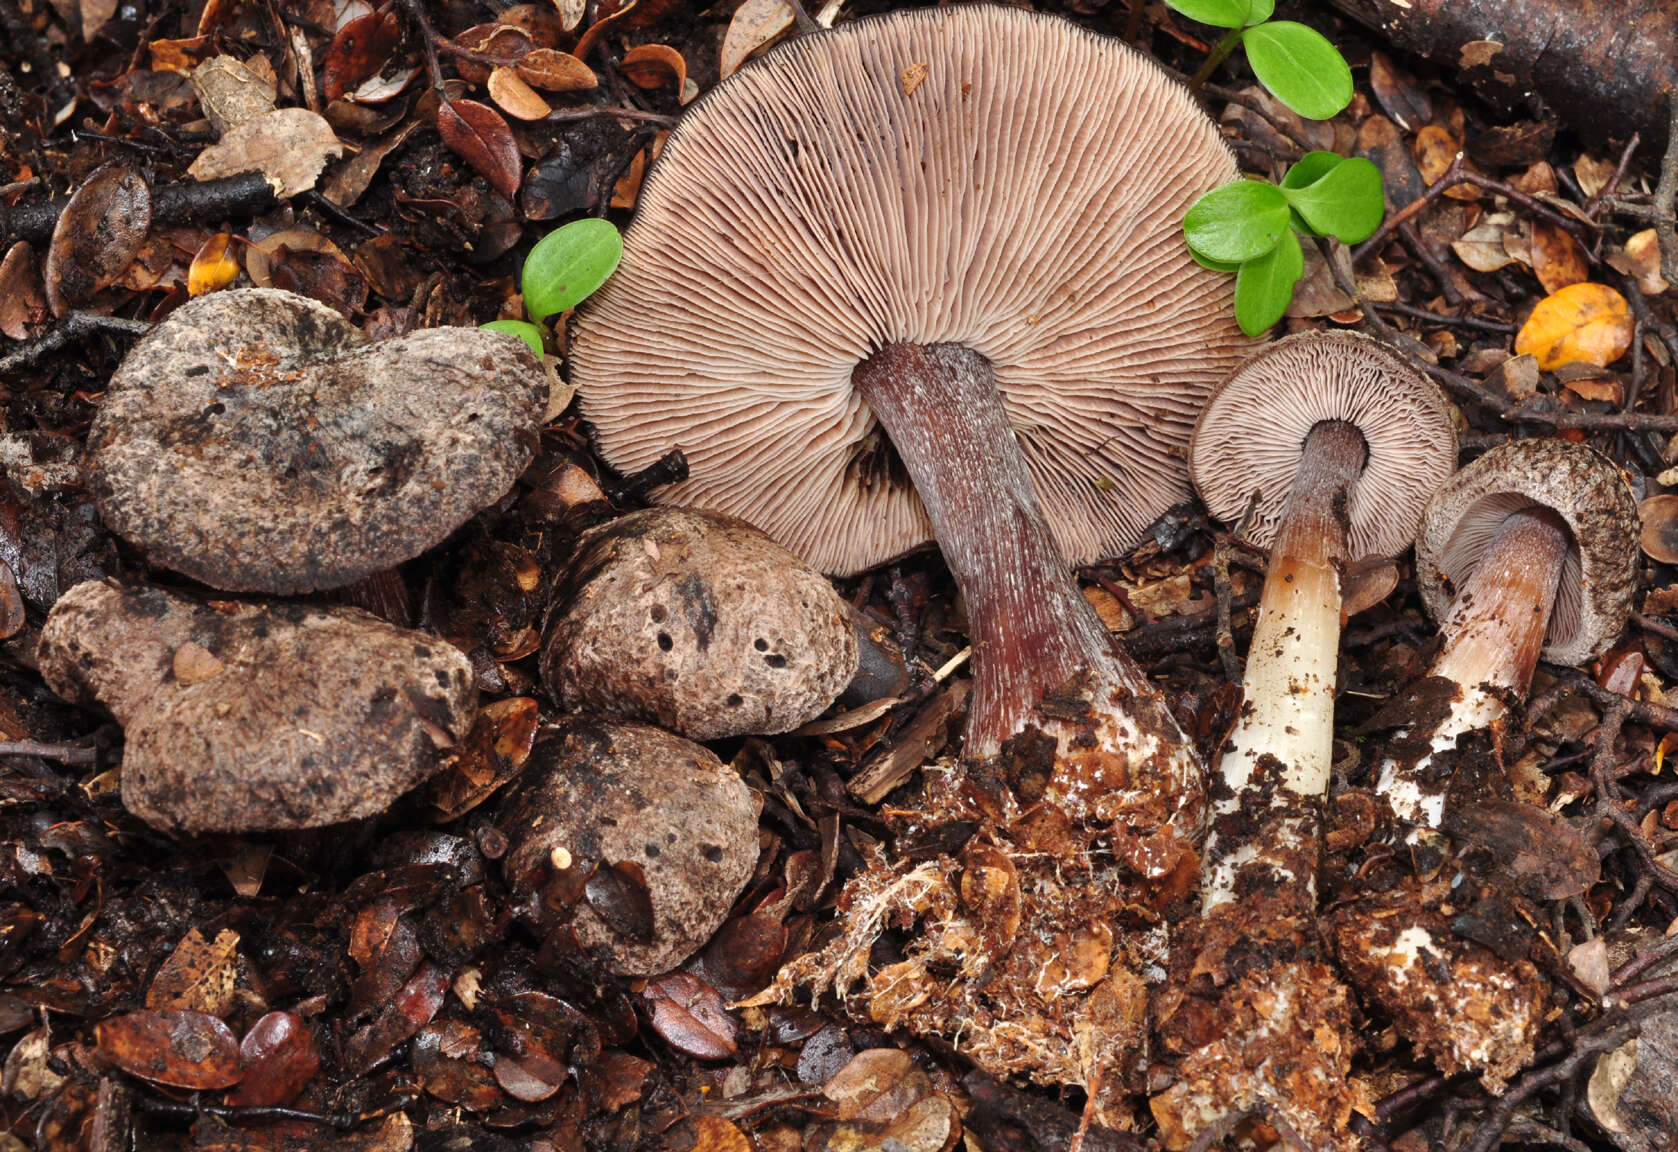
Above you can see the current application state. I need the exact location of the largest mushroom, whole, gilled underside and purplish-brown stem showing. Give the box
[572,5,1248,827]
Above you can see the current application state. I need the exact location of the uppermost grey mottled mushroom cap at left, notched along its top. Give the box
[87,288,547,594]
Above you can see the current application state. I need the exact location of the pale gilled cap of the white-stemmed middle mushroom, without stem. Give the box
[1188,330,1457,560]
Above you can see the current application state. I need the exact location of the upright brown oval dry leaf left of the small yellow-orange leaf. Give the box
[45,164,151,317]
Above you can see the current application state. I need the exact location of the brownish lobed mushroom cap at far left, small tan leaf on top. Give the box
[39,580,477,832]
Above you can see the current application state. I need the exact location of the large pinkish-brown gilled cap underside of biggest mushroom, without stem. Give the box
[572,3,1252,573]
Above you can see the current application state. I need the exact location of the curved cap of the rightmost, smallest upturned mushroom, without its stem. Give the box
[1416,439,1638,664]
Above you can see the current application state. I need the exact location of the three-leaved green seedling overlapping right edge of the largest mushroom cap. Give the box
[1183,153,1386,335]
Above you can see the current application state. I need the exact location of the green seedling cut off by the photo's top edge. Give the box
[1166,0,1352,121]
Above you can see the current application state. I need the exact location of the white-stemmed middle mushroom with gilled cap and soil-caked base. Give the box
[1153,332,1457,1147]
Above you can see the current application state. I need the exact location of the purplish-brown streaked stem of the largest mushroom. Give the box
[851,344,1201,825]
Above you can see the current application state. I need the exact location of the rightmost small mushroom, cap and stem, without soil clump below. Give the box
[1376,439,1638,828]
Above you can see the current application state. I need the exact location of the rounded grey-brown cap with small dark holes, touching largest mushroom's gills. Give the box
[542,508,857,739]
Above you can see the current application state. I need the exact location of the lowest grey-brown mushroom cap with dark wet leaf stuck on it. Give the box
[500,719,762,976]
